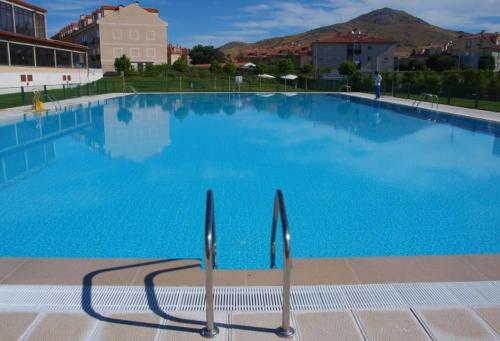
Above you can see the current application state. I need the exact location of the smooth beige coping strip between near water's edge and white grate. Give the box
[0,254,500,287]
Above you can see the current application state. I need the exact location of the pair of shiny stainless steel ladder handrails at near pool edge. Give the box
[201,190,295,338]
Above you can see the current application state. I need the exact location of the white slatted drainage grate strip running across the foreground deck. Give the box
[0,282,500,312]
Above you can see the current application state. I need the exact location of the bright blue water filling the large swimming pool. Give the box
[0,94,500,269]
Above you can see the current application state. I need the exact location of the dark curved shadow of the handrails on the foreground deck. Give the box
[81,259,277,334]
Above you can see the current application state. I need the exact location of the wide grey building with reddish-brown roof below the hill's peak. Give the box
[312,34,396,72]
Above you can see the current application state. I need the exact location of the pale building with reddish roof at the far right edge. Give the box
[452,32,500,71]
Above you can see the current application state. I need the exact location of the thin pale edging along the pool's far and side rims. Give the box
[0,91,500,124]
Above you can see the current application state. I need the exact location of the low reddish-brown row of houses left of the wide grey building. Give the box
[236,44,312,66]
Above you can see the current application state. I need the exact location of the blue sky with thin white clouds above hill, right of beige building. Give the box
[194,0,500,45]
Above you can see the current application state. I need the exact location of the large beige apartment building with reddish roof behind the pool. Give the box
[54,3,168,72]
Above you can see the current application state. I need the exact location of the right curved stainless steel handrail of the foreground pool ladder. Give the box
[271,190,295,338]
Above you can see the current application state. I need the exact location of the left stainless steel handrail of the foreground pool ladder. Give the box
[201,190,219,338]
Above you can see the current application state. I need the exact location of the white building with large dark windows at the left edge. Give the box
[0,0,102,92]
